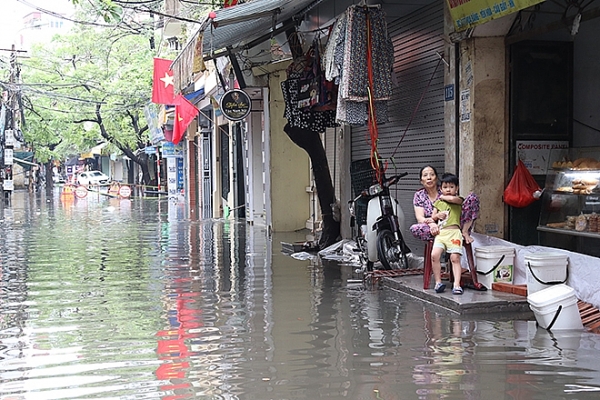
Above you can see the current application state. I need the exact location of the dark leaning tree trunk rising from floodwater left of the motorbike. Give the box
[284,125,340,249]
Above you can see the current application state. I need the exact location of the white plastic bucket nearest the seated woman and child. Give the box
[475,246,515,289]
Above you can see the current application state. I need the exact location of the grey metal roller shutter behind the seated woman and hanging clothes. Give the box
[352,2,444,254]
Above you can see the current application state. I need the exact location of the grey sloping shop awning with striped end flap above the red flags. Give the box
[172,0,323,89]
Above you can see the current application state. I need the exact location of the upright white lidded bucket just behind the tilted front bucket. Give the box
[525,252,569,295]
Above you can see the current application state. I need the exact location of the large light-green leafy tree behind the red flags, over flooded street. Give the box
[22,26,159,188]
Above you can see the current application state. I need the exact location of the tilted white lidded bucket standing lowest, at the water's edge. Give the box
[527,283,583,331]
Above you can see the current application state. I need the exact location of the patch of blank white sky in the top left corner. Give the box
[0,0,72,49]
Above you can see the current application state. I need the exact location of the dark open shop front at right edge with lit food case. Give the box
[507,2,600,257]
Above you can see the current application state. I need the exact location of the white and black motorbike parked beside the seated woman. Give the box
[348,172,408,271]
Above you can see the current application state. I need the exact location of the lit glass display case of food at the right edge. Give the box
[537,148,600,256]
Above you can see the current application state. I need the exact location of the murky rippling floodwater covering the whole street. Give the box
[0,192,600,400]
